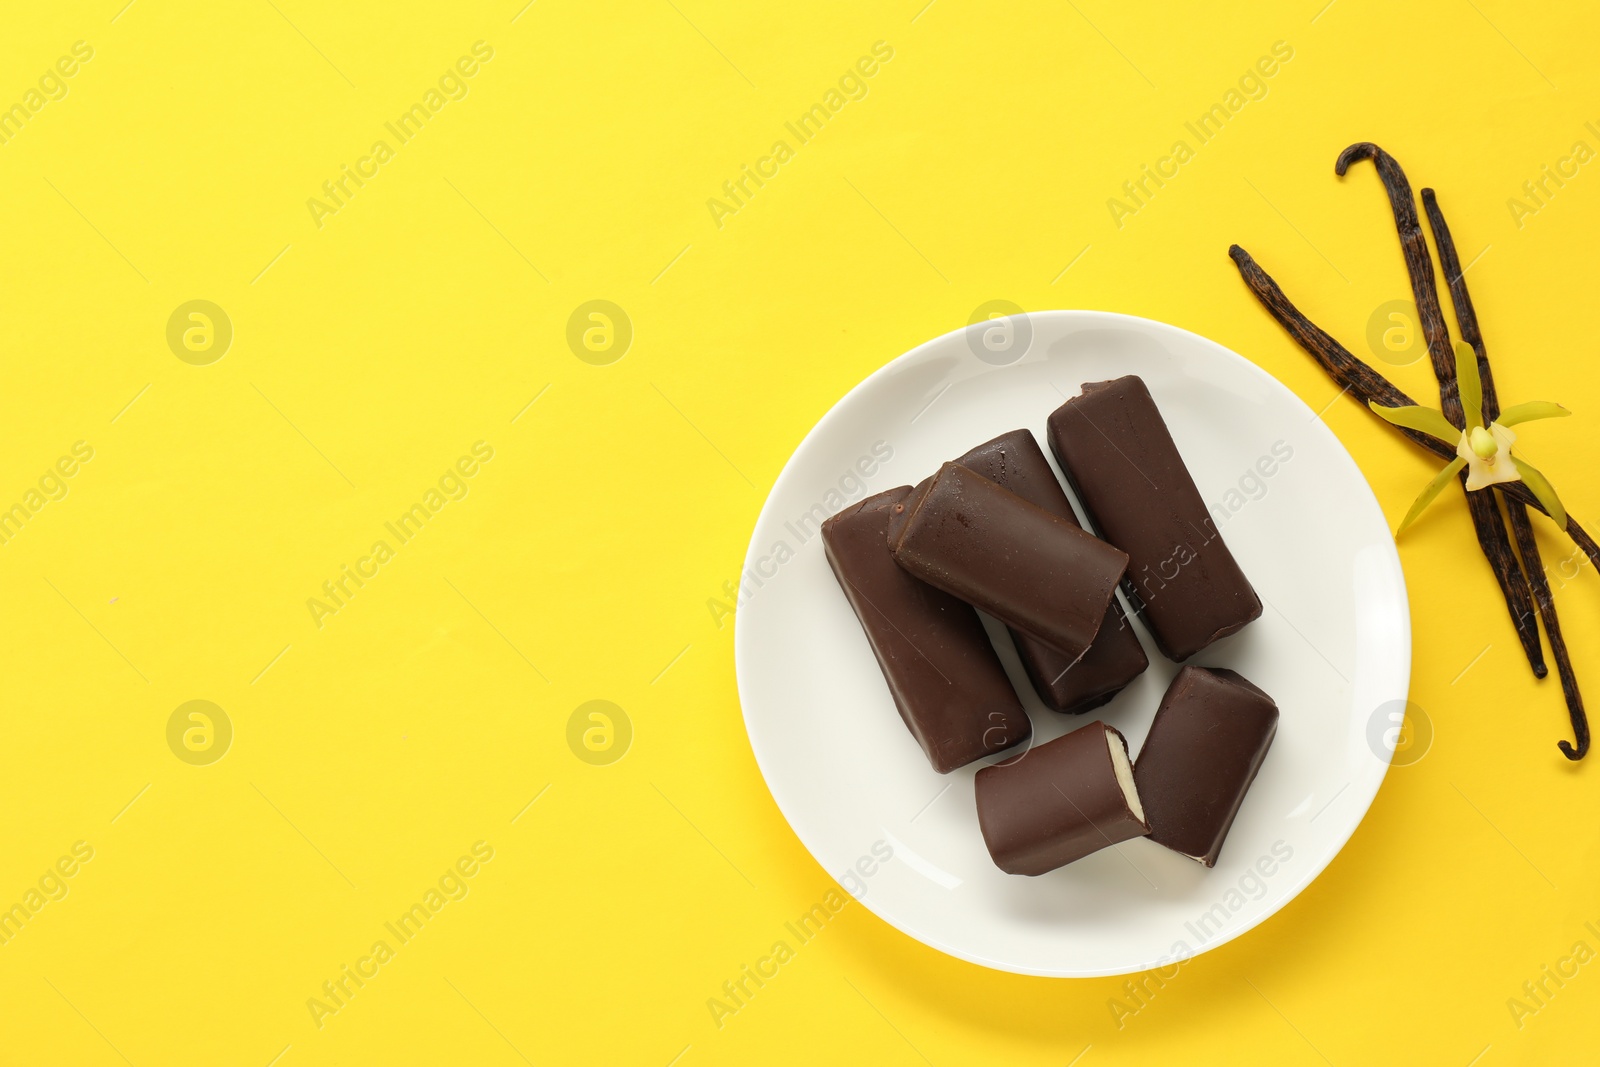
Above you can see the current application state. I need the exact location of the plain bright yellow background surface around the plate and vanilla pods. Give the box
[0,0,1600,1067]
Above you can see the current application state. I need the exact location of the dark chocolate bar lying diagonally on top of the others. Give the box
[886,464,1128,662]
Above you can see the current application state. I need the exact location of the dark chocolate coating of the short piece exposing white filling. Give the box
[973,721,1150,875]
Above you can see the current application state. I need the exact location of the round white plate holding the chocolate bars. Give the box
[734,312,1411,977]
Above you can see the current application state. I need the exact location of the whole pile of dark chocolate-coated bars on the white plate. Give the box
[822,376,1278,875]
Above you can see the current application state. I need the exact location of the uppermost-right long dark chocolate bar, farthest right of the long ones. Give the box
[1050,374,1261,662]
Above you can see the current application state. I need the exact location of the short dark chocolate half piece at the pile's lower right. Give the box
[1133,667,1278,867]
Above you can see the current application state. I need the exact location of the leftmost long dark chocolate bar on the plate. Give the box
[822,485,1034,774]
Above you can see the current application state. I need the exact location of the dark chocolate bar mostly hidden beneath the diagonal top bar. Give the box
[955,430,1150,715]
